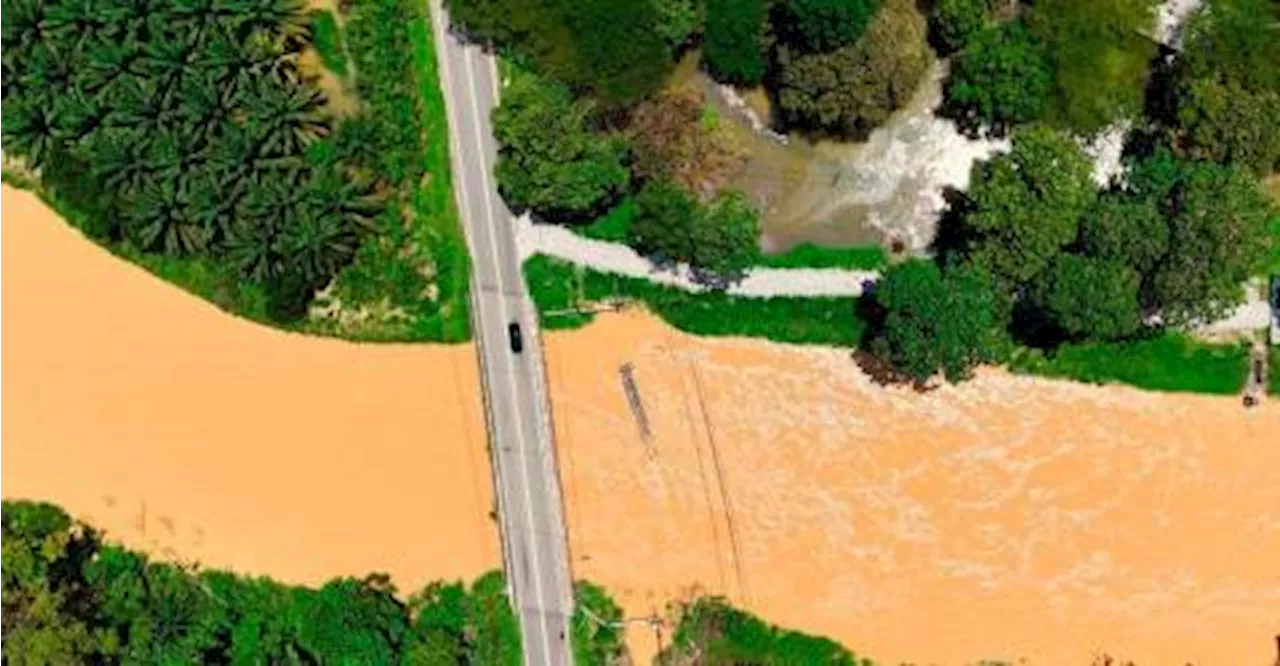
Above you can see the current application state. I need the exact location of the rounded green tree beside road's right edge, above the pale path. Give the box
[493,73,630,220]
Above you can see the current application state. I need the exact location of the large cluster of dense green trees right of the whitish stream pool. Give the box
[864,0,1280,384]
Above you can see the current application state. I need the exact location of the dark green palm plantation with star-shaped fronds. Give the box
[0,0,380,317]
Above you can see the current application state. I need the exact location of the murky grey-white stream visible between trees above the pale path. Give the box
[703,0,1201,252]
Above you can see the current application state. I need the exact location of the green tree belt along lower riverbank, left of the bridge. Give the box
[0,501,521,666]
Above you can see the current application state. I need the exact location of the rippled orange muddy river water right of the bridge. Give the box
[548,314,1280,666]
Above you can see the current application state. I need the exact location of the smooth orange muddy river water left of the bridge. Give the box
[0,187,500,592]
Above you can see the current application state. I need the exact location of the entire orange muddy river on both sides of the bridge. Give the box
[0,188,1280,666]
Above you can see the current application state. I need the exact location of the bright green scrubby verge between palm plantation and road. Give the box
[308,0,471,342]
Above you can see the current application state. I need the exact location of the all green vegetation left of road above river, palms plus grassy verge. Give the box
[0,0,466,339]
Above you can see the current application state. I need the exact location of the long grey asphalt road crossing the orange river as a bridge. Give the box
[430,0,573,666]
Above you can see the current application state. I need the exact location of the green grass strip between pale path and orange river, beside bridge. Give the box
[525,255,865,347]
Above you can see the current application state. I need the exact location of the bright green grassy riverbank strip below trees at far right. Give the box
[1009,333,1248,394]
